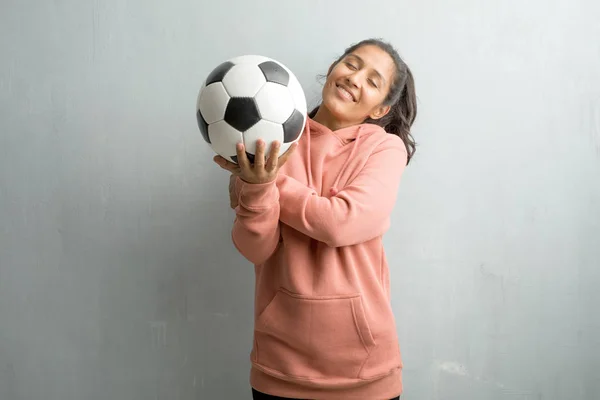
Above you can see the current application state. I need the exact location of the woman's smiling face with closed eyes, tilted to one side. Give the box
[323,45,396,125]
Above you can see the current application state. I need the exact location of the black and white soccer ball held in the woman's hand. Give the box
[196,55,307,164]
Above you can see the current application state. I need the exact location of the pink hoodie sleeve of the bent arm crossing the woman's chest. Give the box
[277,137,407,247]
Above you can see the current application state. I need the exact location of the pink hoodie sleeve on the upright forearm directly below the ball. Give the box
[231,178,280,265]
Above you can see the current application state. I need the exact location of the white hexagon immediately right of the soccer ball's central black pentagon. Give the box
[254,82,294,124]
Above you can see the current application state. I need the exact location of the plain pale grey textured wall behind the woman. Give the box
[0,0,600,400]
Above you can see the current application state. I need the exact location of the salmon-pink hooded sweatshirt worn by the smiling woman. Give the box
[232,119,407,400]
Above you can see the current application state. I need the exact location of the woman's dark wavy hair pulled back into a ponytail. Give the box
[309,39,417,164]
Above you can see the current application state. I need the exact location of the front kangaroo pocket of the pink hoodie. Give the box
[254,289,375,386]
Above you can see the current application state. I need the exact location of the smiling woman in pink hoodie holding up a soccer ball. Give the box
[215,39,416,400]
